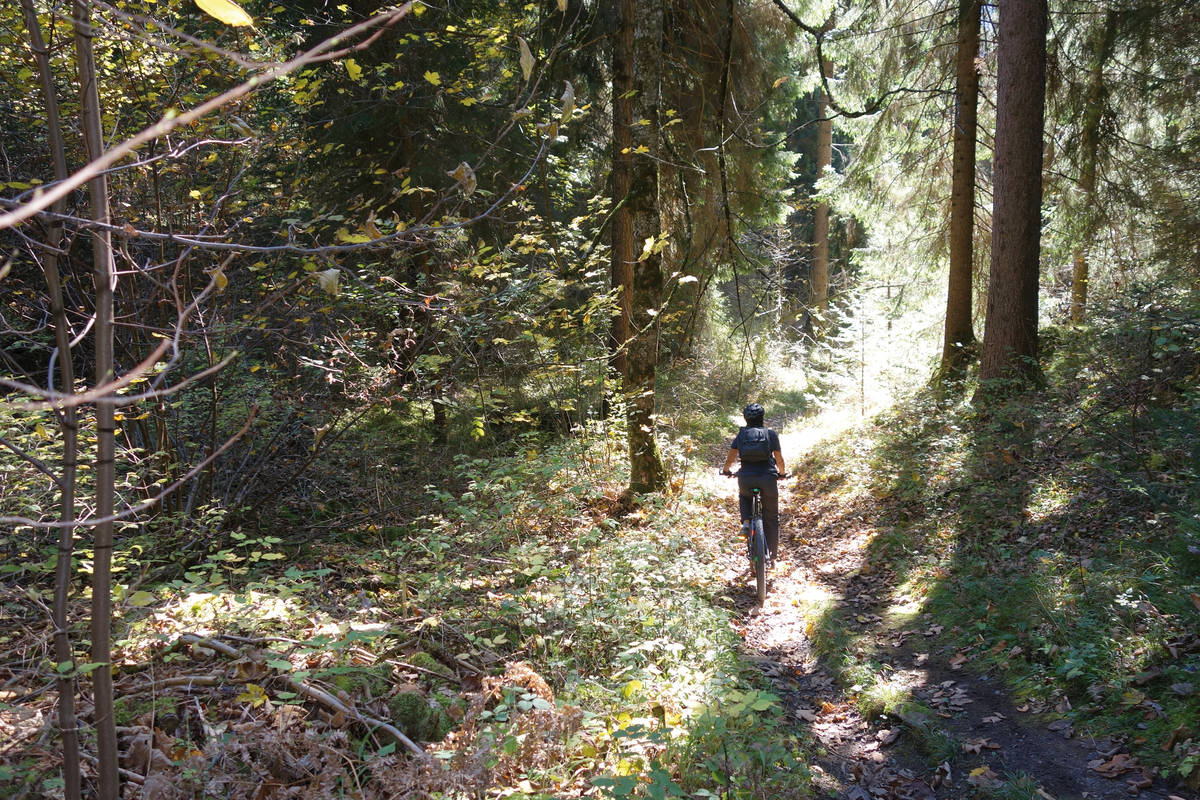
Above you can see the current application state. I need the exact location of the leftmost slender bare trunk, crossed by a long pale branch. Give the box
[20,0,80,800]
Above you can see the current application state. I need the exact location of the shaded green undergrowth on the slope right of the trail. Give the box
[803,291,1200,788]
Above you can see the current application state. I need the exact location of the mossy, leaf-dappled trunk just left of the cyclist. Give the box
[620,0,666,494]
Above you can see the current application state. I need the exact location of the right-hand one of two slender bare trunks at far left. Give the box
[74,0,119,800]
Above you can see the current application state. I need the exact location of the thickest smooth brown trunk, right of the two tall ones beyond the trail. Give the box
[979,0,1048,388]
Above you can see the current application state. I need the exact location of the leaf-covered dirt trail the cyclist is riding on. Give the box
[705,450,1196,800]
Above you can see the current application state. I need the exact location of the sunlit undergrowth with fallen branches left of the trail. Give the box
[0,402,809,798]
